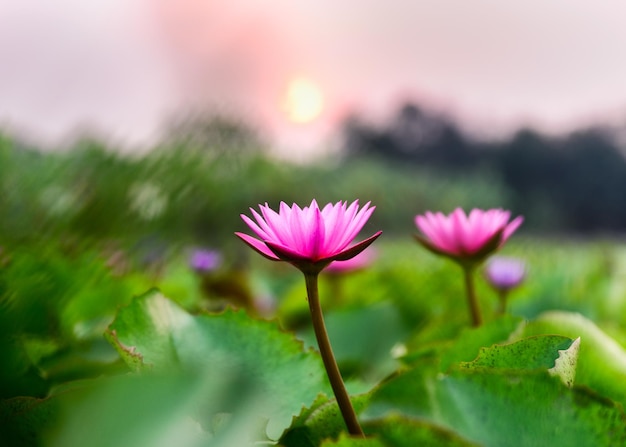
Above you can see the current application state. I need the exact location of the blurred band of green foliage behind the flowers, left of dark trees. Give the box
[0,128,505,252]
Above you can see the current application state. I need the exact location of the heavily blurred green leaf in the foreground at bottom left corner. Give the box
[0,372,264,447]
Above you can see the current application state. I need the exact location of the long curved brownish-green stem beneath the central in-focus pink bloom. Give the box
[304,273,365,438]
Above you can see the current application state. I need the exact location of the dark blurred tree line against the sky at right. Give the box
[342,103,626,234]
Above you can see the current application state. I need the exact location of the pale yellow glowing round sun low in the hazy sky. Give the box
[283,78,324,123]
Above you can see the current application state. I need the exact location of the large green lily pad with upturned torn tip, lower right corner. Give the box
[363,336,626,446]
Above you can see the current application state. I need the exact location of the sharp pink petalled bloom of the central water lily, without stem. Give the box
[235,200,382,273]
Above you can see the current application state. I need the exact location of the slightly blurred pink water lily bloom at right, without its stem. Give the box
[415,208,524,263]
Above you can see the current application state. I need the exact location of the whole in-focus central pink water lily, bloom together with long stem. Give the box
[235,200,382,437]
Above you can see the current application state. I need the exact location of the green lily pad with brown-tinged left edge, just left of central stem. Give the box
[106,291,331,439]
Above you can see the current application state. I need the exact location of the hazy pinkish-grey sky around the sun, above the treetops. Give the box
[0,0,626,157]
